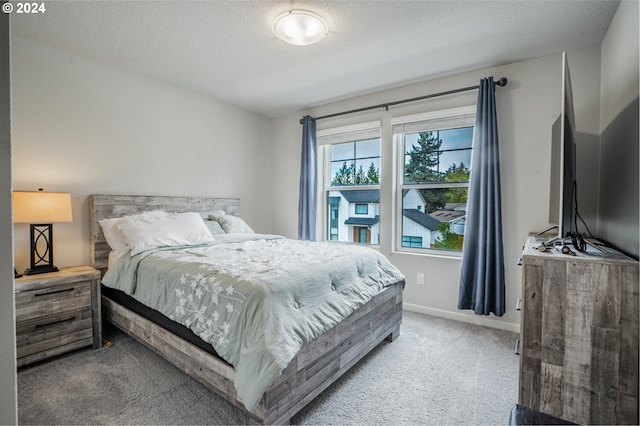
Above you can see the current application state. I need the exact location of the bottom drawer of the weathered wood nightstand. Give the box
[16,309,93,366]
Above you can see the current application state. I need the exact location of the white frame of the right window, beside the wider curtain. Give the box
[391,105,477,258]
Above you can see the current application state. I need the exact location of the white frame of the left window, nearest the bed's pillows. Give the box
[316,120,382,249]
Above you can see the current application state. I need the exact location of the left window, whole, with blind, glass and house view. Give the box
[317,122,381,245]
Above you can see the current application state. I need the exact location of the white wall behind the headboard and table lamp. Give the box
[11,37,272,270]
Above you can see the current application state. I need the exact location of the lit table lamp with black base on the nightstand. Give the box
[13,189,72,275]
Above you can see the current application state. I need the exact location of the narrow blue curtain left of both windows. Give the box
[298,115,317,241]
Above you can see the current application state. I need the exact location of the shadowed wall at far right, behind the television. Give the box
[598,1,640,256]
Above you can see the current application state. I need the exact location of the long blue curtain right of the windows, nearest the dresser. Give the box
[458,77,505,316]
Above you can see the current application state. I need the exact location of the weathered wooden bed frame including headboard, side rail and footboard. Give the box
[89,195,404,424]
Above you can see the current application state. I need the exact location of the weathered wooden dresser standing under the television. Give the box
[518,236,639,424]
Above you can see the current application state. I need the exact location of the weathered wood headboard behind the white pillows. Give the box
[89,194,240,275]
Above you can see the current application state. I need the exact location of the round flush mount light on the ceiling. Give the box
[272,10,329,46]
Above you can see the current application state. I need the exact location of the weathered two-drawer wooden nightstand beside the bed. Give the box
[14,266,102,367]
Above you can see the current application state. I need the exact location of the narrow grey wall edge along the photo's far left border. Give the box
[0,13,18,425]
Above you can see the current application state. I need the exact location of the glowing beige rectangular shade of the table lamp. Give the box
[13,191,73,223]
